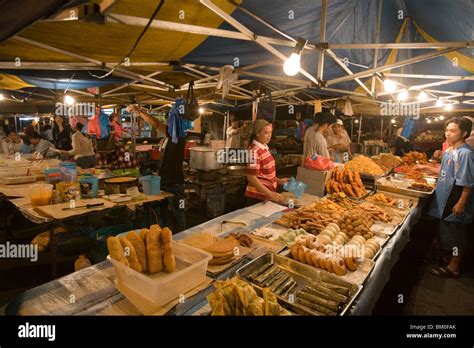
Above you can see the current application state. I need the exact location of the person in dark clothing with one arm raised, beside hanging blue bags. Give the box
[129,104,186,233]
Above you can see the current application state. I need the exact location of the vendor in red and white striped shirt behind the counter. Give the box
[245,119,288,205]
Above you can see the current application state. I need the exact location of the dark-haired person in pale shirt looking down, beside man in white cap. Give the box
[303,112,336,158]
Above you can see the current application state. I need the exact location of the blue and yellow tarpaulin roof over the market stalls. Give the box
[0,0,474,114]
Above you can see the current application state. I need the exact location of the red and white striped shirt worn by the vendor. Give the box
[245,140,277,201]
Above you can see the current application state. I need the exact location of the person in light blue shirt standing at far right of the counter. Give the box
[414,117,474,278]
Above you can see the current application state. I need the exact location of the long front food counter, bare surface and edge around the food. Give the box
[7,189,424,315]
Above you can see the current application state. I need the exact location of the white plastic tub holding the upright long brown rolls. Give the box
[107,234,212,306]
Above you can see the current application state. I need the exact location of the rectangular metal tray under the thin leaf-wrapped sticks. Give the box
[237,253,362,316]
